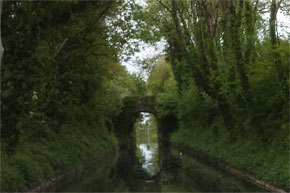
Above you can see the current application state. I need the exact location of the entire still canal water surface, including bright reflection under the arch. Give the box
[49,113,265,192]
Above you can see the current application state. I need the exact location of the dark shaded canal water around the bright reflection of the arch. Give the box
[52,141,261,192]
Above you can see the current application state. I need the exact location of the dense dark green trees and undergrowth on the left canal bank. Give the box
[1,1,142,191]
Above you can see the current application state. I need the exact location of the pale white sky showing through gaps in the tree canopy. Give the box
[122,0,290,73]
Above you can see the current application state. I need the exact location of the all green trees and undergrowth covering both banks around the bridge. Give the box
[1,0,290,191]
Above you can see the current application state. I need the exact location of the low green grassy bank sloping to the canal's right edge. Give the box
[171,123,289,190]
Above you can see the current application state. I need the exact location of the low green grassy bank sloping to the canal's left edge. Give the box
[1,119,117,192]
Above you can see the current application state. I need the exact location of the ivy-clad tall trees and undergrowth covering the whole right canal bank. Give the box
[140,0,290,189]
